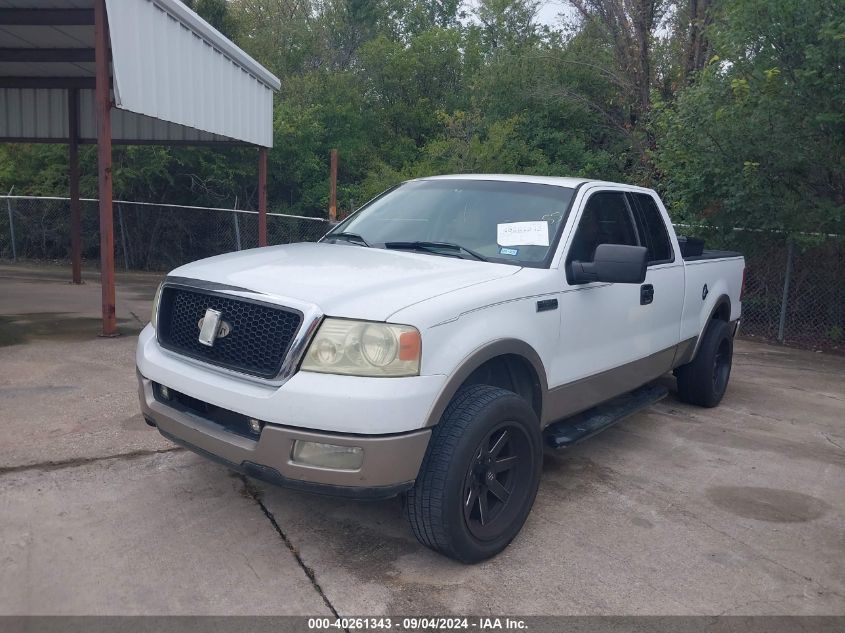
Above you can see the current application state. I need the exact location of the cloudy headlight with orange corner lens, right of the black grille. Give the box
[302,318,421,377]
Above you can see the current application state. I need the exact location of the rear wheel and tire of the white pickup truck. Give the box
[675,319,733,407]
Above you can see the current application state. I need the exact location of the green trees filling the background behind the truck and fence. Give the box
[0,0,845,237]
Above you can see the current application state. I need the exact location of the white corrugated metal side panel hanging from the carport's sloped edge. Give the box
[106,0,278,147]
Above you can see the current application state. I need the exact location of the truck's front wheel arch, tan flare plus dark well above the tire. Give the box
[426,339,548,427]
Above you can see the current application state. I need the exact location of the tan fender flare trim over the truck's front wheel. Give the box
[425,338,548,428]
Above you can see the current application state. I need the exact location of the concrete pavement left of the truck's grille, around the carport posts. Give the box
[0,265,166,468]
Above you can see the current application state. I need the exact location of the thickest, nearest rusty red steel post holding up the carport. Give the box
[94,0,118,336]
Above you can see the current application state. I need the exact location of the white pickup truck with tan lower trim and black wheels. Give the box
[136,175,744,562]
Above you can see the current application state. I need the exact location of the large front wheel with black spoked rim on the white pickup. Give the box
[406,385,543,563]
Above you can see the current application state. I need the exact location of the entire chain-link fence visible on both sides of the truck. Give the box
[0,196,845,349]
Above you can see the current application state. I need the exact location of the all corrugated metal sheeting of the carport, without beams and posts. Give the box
[0,0,279,147]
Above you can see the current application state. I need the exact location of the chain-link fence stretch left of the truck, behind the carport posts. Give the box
[0,196,331,271]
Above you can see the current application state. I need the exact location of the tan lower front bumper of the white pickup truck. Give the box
[138,372,431,498]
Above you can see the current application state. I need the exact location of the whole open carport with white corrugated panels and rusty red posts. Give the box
[0,0,280,335]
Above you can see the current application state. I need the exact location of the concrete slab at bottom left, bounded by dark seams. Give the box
[0,451,332,616]
